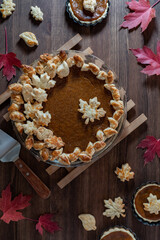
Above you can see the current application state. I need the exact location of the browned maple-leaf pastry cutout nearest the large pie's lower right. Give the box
[115,163,134,182]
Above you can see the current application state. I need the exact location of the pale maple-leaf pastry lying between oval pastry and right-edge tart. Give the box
[103,197,126,219]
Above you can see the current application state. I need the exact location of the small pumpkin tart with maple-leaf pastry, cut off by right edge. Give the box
[133,183,160,225]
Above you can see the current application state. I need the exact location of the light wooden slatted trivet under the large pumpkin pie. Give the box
[0,34,147,189]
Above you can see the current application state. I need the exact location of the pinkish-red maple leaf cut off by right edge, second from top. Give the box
[131,41,160,75]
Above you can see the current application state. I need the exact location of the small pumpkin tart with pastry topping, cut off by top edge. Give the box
[66,0,109,26]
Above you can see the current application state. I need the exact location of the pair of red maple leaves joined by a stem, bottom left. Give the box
[0,184,60,235]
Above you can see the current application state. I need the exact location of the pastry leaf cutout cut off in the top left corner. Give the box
[0,0,16,18]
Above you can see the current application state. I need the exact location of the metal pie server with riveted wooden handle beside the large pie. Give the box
[0,129,51,199]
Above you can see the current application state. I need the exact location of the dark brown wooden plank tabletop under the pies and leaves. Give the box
[0,0,160,240]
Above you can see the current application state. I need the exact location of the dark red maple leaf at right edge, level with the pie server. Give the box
[137,136,160,165]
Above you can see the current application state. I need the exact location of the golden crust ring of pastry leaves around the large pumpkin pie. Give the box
[8,51,124,165]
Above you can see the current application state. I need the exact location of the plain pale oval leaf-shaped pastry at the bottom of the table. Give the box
[78,214,97,231]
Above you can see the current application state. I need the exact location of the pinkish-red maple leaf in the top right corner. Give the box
[121,0,156,32]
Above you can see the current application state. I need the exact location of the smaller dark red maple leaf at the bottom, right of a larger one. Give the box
[36,214,60,235]
